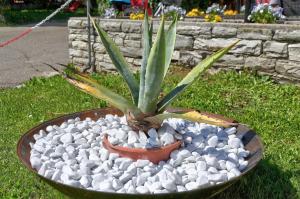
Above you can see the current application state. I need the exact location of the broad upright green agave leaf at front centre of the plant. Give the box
[139,18,166,114]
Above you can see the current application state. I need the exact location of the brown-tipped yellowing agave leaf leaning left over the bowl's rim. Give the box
[67,74,141,117]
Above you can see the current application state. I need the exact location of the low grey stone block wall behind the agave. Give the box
[68,18,300,84]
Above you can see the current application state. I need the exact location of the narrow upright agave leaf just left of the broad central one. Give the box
[139,11,153,106]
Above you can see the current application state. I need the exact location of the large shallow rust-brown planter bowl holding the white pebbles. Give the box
[17,108,263,199]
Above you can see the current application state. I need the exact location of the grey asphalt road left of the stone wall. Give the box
[0,23,68,88]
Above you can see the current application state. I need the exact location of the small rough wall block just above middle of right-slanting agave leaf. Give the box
[179,51,203,66]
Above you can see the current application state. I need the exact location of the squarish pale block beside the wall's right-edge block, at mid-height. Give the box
[263,41,288,57]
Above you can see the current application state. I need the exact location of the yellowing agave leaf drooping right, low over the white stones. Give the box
[144,111,237,127]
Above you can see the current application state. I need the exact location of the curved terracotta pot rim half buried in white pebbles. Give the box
[103,135,181,164]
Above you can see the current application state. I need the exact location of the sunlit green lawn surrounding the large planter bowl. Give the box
[0,72,300,199]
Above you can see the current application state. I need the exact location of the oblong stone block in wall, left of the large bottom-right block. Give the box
[245,57,276,72]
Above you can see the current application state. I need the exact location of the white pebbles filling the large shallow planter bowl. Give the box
[30,115,249,194]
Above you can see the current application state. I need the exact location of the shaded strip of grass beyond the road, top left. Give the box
[0,8,86,26]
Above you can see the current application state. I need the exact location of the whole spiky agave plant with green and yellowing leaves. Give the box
[66,13,238,131]
